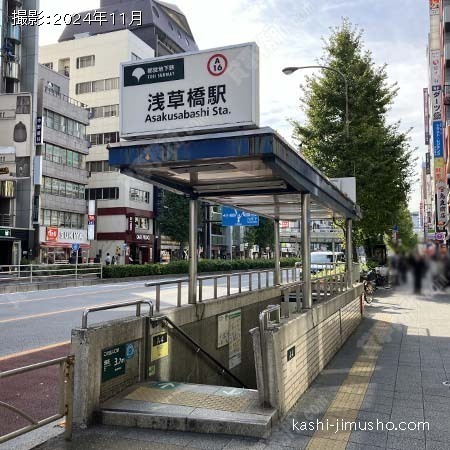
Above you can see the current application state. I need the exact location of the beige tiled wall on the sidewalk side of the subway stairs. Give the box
[252,286,362,416]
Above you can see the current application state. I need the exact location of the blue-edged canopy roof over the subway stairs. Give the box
[109,128,361,220]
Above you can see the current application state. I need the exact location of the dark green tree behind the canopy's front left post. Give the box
[158,191,189,252]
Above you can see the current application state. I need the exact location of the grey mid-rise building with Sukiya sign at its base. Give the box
[33,65,90,263]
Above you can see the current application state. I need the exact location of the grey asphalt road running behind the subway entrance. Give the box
[0,274,278,357]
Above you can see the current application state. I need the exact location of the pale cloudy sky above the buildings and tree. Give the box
[40,0,429,210]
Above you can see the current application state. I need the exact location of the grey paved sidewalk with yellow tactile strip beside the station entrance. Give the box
[30,287,450,450]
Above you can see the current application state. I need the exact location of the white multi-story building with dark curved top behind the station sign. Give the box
[39,0,197,263]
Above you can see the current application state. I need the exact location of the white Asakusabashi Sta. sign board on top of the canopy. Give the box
[120,43,259,139]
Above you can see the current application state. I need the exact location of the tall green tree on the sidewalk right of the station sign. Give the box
[292,19,413,253]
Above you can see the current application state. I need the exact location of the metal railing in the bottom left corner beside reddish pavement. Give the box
[0,355,74,444]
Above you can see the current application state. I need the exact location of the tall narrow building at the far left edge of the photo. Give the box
[0,0,39,264]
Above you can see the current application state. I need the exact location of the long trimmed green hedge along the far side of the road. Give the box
[103,258,300,278]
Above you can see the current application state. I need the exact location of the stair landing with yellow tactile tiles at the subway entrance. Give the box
[100,381,278,438]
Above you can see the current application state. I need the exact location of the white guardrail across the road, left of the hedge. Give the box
[0,263,103,286]
